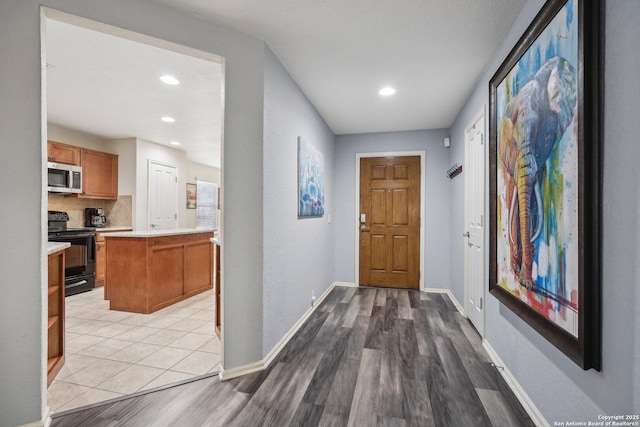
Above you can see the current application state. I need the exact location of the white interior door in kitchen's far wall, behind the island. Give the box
[149,160,178,230]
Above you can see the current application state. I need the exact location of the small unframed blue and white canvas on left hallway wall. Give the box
[298,136,324,218]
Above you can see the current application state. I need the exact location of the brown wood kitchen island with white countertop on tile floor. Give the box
[104,228,213,314]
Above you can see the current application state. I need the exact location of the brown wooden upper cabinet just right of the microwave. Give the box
[78,148,118,200]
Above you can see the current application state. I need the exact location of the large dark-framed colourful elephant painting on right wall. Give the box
[489,0,604,370]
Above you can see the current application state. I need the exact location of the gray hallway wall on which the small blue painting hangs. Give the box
[262,47,335,356]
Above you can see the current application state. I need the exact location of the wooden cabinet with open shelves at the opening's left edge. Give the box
[47,249,65,386]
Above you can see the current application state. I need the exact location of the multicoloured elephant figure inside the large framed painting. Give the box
[497,56,577,290]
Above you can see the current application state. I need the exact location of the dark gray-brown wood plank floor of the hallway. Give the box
[52,287,534,427]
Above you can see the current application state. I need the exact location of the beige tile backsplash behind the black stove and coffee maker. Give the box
[48,194,133,228]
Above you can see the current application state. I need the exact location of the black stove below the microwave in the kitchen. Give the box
[47,211,96,296]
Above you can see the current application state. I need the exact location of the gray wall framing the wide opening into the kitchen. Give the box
[0,0,264,425]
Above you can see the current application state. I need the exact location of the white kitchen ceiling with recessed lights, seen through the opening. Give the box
[46,20,222,167]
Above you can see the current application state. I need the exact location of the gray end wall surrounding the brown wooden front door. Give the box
[334,129,452,290]
